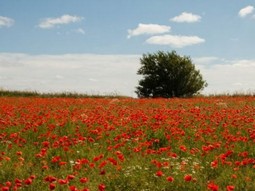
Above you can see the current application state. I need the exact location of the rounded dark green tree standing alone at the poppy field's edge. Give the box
[135,51,207,98]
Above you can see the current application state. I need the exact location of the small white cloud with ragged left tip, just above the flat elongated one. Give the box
[127,23,171,38]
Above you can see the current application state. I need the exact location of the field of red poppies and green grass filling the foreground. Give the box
[0,97,255,191]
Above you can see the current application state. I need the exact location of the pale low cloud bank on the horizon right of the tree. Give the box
[192,57,255,94]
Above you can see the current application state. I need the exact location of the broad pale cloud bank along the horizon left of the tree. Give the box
[0,53,140,96]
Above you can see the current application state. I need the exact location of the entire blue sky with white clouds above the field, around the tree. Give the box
[0,0,255,96]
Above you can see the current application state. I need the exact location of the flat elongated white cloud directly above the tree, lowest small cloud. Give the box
[146,35,205,48]
